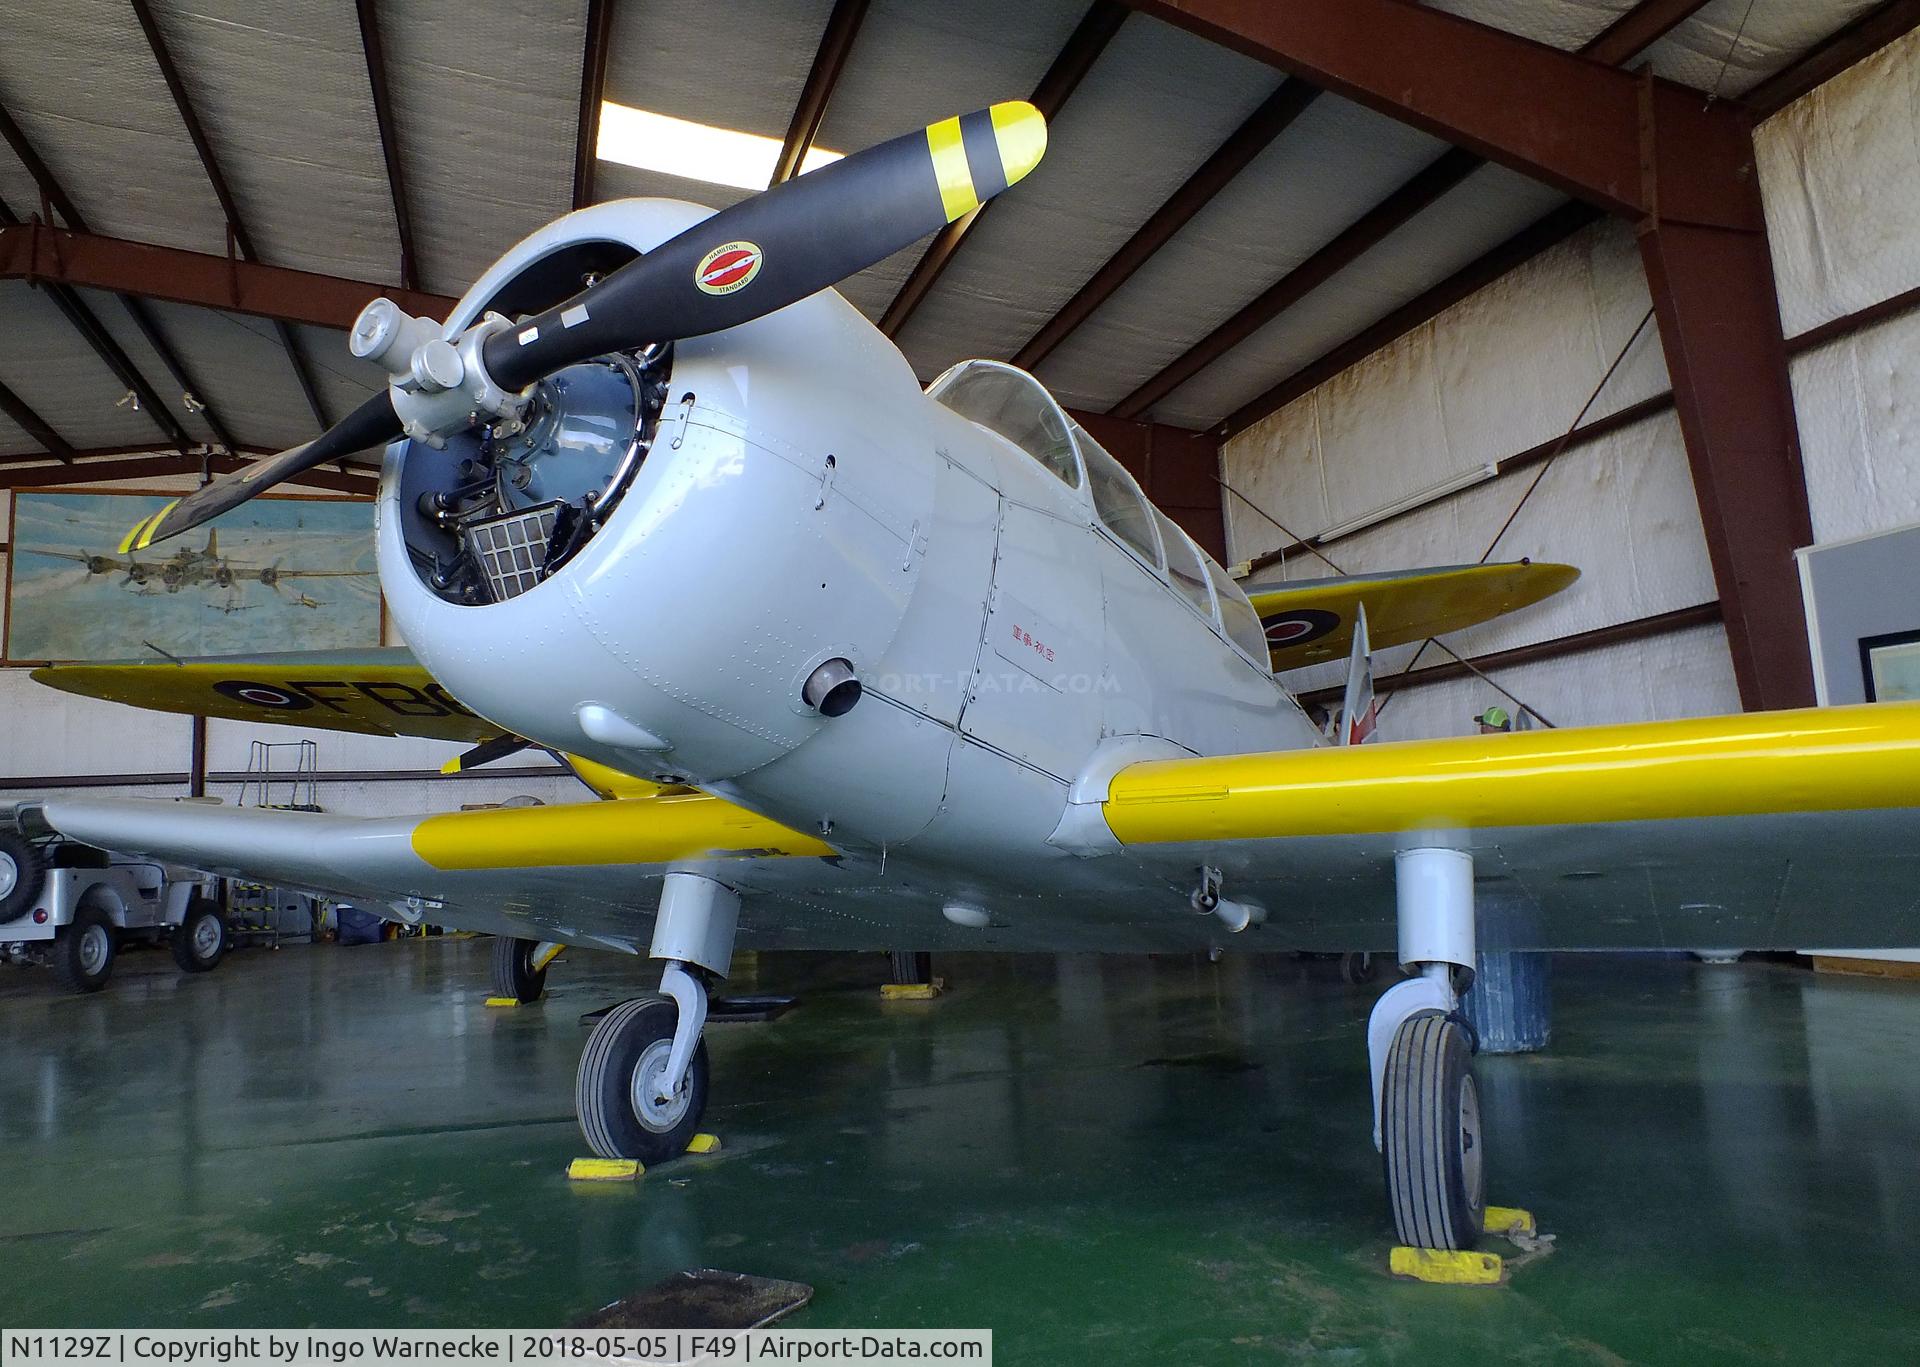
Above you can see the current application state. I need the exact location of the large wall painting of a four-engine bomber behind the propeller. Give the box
[4,490,380,662]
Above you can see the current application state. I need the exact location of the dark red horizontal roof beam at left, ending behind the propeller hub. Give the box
[0,223,453,330]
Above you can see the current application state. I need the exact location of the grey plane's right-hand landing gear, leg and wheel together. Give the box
[1367,847,1486,1250]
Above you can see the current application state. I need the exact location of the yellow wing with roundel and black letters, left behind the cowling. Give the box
[33,647,501,743]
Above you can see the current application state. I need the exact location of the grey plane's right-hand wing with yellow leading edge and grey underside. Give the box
[1102,706,1920,950]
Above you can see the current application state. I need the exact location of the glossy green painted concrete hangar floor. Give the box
[0,939,1920,1363]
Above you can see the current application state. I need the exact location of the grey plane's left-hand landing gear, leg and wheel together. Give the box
[574,872,739,1163]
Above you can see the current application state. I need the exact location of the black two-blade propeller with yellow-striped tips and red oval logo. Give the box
[121,100,1046,551]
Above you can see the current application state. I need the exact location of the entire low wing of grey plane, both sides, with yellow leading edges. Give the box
[17,703,1920,952]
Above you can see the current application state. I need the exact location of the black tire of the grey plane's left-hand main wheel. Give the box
[574,996,708,1163]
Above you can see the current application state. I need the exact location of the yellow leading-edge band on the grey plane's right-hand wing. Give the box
[1104,703,1920,845]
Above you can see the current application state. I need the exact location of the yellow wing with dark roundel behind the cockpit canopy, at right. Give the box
[1242,561,1580,670]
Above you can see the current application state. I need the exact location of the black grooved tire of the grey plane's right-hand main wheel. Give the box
[1380,1012,1486,1250]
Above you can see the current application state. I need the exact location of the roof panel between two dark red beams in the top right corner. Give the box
[1645,0,1880,96]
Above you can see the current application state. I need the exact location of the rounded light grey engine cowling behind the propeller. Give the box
[378,200,931,783]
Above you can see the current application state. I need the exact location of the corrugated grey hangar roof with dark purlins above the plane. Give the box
[0,0,1896,476]
